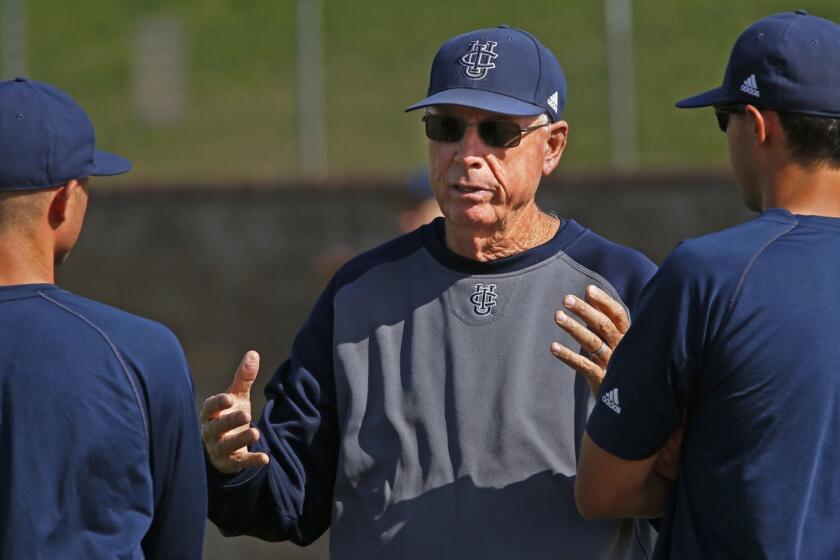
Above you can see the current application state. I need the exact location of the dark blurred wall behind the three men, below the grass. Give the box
[58,176,752,560]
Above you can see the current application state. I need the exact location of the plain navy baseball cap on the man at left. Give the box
[0,78,131,191]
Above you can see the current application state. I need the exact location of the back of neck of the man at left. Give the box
[0,235,55,286]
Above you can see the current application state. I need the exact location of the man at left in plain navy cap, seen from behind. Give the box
[0,78,206,560]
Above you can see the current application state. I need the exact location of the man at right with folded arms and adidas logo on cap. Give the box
[576,11,840,559]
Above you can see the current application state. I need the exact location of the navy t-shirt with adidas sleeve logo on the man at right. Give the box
[587,209,840,559]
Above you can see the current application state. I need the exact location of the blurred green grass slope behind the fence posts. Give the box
[6,0,840,183]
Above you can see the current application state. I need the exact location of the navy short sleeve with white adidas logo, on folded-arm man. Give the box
[586,243,723,460]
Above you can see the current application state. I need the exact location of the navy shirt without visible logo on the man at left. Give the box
[0,284,206,560]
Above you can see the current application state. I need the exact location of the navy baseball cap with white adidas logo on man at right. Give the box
[677,10,840,117]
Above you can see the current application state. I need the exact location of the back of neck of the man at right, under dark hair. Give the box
[763,163,840,218]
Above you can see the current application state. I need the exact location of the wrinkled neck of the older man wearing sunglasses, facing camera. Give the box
[445,205,560,262]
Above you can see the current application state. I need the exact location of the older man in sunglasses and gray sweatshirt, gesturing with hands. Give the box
[202,26,654,559]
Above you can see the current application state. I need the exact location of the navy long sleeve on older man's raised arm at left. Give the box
[206,281,339,545]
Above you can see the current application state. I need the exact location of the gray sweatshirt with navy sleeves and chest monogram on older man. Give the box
[208,219,655,560]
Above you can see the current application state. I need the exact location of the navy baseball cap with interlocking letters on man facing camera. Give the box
[406,25,566,122]
